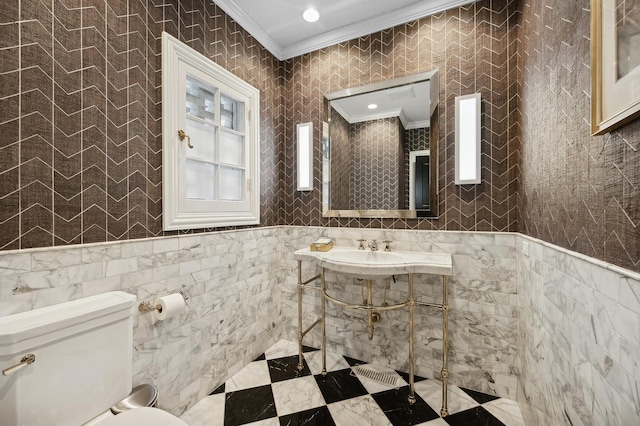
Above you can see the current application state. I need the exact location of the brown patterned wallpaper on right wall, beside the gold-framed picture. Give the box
[519,0,640,271]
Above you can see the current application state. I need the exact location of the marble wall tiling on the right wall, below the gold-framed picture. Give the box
[518,236,640,426]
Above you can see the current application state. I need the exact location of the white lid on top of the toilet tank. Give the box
[0,291,136,352]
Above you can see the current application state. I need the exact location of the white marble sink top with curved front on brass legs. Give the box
[294,247,452,279]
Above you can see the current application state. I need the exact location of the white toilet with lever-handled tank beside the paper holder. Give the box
[0,291,187,426]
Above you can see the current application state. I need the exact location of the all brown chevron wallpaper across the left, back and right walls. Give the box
[0,0,640,271]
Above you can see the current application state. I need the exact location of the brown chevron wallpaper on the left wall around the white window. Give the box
[0,0,283,249]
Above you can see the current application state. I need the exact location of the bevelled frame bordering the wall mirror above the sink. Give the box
[321,70,440,219]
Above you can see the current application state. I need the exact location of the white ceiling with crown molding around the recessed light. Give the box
[213,0,477,60]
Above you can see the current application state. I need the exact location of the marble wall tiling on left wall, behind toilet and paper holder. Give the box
[0,228,283,415]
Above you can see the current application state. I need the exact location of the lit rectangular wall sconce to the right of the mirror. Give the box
[456,93,481,185]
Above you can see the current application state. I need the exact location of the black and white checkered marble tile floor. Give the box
[182,341,524,426]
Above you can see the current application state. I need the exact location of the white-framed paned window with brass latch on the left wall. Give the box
[162,33,260,230]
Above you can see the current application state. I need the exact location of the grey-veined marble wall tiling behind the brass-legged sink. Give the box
[281,226,518,399]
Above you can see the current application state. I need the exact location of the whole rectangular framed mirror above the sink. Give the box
[322,71,439,218]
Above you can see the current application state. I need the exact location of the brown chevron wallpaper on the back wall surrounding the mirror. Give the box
[279,0,520,231]
